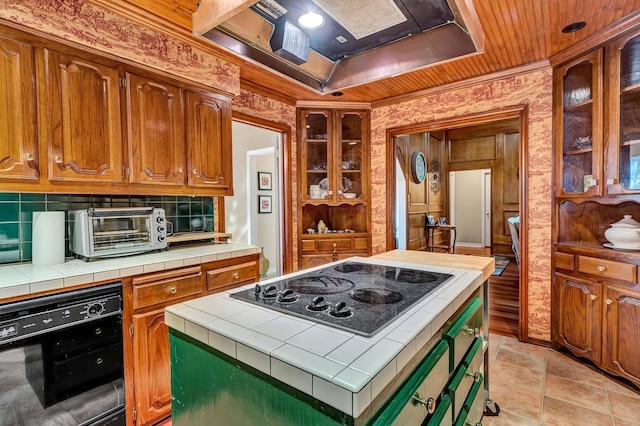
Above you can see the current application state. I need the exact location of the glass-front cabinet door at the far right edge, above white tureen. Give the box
[608,34,640,194]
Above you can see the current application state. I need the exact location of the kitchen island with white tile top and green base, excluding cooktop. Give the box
[165,250,494,425]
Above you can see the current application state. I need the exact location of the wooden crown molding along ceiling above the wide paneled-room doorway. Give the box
[371,60,550,108]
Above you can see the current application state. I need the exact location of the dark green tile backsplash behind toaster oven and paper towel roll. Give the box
[0,193,214,264]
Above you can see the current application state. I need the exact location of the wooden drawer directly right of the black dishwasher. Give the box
[133,266,202,309]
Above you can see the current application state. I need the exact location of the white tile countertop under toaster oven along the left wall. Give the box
[0,243,260,303]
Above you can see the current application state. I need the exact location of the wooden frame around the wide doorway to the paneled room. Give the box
[386,105,529,342]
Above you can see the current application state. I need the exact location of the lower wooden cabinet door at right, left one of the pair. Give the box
[555,274,602,362]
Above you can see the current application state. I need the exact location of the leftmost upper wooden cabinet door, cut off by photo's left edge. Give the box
[0,37,40,179]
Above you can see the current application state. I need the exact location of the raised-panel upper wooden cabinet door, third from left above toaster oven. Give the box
[127,74,186,185]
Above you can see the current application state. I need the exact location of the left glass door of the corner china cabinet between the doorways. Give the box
[300,111,333,201]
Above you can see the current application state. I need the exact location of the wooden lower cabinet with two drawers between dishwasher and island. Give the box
[125,254,260,426]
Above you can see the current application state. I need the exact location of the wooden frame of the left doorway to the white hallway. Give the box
[232,111,293,274]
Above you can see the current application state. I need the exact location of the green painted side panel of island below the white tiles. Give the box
[169,328,354,426]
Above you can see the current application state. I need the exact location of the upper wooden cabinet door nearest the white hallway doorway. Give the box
[186,91,233,195]
